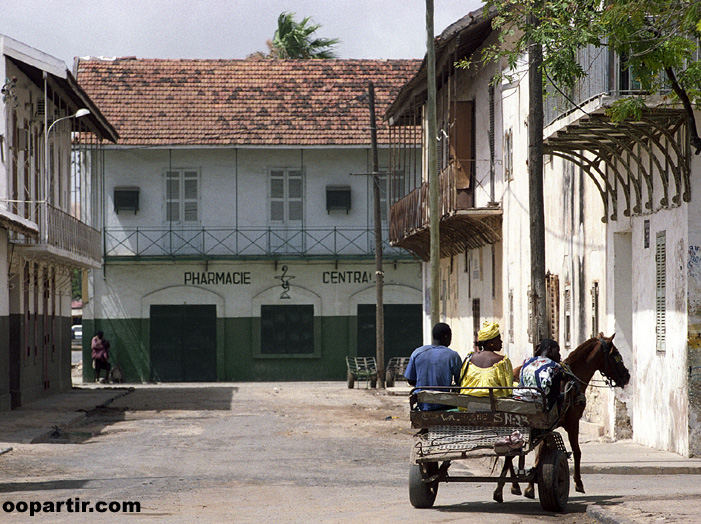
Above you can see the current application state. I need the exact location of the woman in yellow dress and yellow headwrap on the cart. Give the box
[460,321,513,397]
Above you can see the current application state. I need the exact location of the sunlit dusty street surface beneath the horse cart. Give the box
[0,382,701,524]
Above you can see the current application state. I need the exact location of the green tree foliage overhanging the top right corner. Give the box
[485,0,701,154]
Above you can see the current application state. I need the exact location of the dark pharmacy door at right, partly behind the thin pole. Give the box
[358,304,423,364]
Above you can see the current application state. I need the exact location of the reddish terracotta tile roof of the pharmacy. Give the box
[75,58,421,146]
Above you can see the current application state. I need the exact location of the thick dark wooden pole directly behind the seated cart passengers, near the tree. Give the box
[528,11,548,348]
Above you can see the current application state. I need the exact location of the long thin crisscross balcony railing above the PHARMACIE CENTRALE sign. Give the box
[105,227,409,259]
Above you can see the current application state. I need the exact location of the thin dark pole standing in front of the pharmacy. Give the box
[368,82,385,389]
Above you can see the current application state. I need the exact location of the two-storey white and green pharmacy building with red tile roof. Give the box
[75,58,422,382]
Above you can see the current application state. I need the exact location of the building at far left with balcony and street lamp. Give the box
[0,35,117,409]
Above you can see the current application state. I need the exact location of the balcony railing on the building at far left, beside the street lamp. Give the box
[10,204,102,263]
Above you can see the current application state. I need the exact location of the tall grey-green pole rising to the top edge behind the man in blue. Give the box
[426,0,440,327]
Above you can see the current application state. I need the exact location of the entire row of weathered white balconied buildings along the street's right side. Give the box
[387,10,701,455]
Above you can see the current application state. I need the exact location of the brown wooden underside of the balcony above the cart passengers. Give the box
[392,208,503,262]
